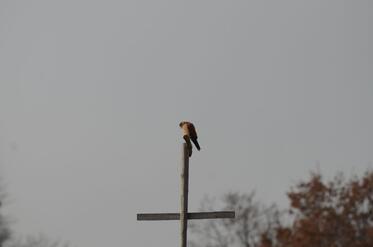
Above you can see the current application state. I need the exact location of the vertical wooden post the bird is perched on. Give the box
[180,143,189,247]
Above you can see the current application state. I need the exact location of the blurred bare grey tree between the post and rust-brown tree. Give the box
[191,192,280,247]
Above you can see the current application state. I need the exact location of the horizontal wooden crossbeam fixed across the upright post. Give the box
[137,211,235,221]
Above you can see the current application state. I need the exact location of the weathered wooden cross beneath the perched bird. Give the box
[137,143,235,247]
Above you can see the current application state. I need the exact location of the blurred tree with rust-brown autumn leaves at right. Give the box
[270,172,373,247]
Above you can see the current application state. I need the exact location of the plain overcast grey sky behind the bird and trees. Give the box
[0,0,373,247]
